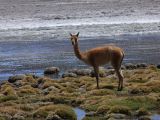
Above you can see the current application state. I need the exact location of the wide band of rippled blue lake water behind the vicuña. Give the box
[0,33,160,80]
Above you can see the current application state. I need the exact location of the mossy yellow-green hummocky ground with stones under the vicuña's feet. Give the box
[0,64,160,120]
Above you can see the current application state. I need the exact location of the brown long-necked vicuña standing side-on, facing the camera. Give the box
[70,32,124,90]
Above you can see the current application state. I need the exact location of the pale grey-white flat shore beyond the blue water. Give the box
[0,0,160,41]
